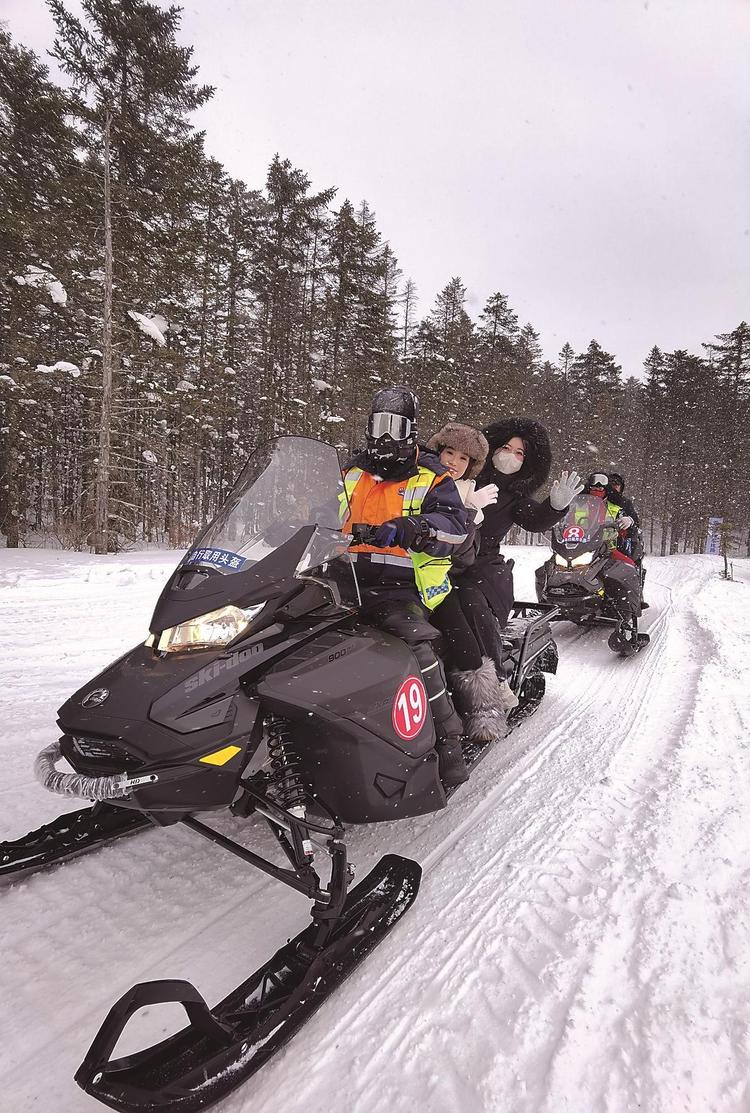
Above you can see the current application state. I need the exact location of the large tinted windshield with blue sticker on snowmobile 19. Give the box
[181,436,351,573]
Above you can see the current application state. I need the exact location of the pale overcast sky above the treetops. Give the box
[5,0,750,373]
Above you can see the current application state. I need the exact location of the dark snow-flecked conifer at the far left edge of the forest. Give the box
[0,27,80,546]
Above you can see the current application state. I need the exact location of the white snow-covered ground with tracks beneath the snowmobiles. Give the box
[0,549,750,1113]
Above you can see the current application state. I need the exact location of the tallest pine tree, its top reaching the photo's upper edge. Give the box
[49,0,213,552]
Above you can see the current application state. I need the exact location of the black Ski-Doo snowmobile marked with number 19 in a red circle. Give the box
[0,437,556,1113]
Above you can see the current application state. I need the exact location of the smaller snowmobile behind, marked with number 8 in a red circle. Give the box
[536,494,650,657]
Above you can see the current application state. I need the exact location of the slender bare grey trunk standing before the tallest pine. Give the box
[93,109,112,553]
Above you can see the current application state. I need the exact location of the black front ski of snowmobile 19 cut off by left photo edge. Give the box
[0,804,152,885]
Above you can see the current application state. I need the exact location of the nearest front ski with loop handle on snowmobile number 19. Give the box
[76,855,422,1113]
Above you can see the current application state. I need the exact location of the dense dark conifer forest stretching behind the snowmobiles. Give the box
[0,0,750,555]
